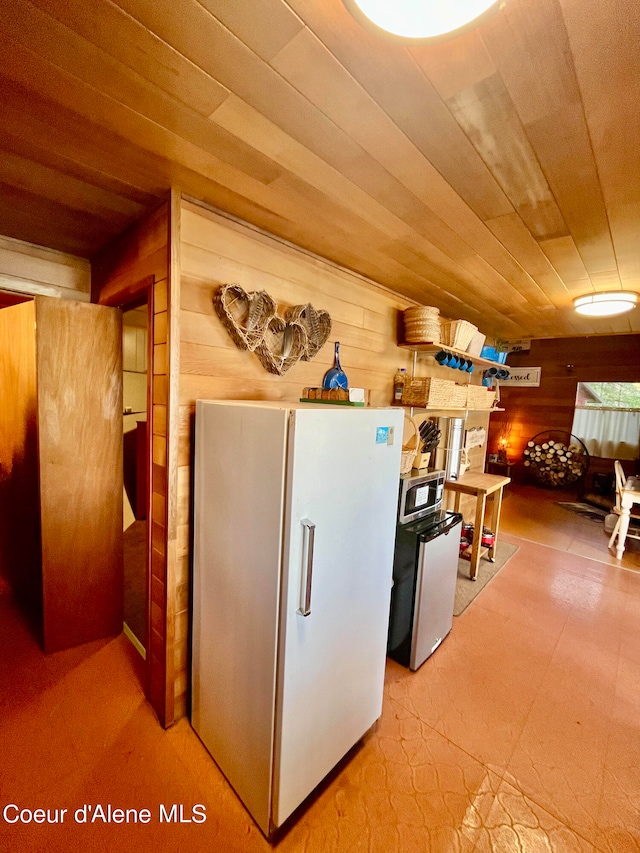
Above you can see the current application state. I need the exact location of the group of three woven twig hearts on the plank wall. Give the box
[213,284,331,376]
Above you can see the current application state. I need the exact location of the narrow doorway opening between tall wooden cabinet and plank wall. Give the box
[122,297,149,659]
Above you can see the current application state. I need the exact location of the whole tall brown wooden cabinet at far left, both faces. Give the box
[0,297,122,652]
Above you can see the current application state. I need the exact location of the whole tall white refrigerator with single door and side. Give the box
[192,400,403,836]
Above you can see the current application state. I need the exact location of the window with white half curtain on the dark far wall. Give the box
[571,382,640,459]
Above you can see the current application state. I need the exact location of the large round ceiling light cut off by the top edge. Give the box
[343,0,506,41]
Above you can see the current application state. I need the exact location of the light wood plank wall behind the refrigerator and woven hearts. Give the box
[175,202,424,707]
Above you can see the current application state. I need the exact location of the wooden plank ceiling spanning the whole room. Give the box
[0,0,640,339]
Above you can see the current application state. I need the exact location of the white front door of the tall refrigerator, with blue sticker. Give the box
[274,407,403,826]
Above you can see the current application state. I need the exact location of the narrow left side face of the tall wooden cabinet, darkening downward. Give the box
[0,300,42,633]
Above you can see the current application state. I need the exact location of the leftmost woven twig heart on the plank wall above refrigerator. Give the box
[213,284,276,352]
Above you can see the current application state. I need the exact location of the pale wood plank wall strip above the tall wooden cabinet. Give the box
[0,236,91,302]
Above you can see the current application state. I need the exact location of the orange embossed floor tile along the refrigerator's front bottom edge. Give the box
[277,699,500,853]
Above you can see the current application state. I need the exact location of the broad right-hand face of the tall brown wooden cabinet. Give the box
[36,297,123,652]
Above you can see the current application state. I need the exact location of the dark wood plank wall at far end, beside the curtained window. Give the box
[488,335,640,476]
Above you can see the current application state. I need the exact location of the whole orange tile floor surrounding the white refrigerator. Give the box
[0,536,640,853]
